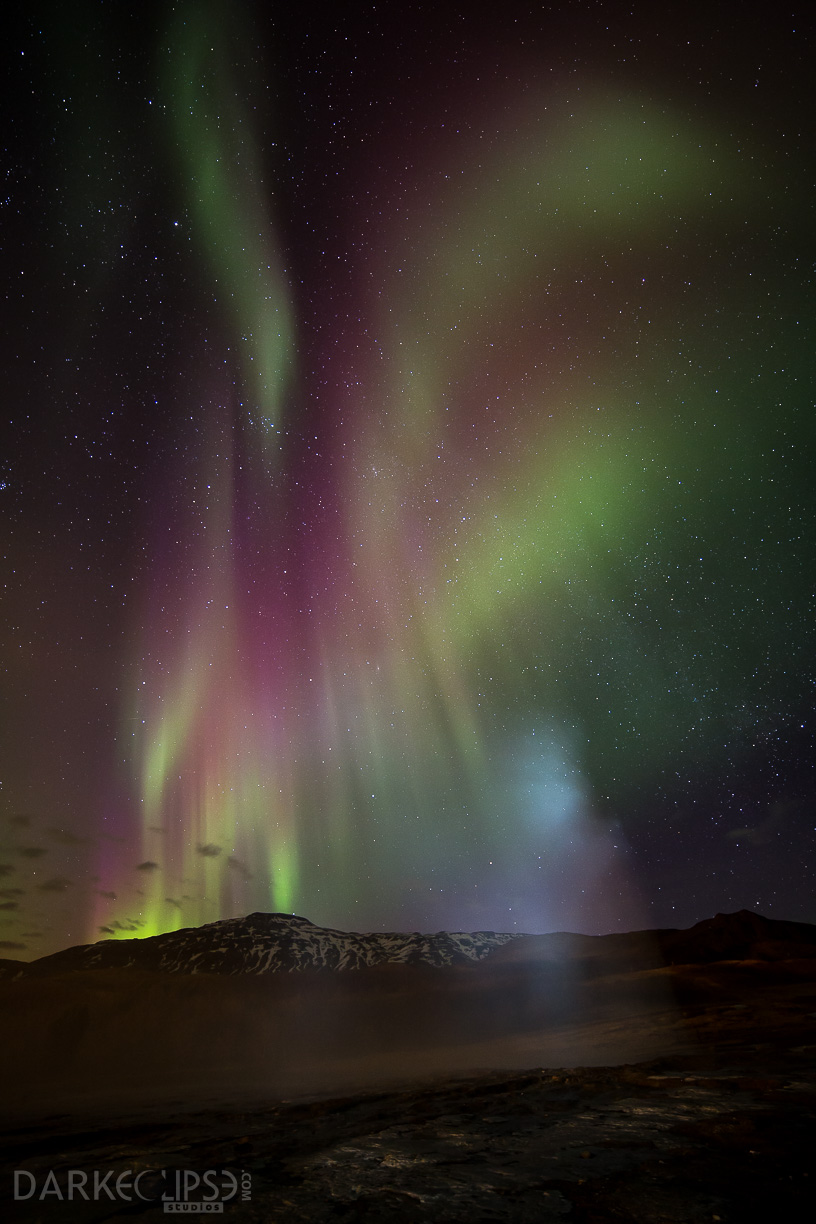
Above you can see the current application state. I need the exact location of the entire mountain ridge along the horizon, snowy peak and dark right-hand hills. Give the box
[0,909,816,978]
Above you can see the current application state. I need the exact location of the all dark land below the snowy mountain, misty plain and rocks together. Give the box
[0,916,816,1224]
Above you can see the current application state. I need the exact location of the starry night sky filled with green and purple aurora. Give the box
[0,0,816,958]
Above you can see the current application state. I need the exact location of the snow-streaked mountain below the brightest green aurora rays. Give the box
[7,913,517,977]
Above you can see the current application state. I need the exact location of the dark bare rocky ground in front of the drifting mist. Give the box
[0,961,816,1224]
